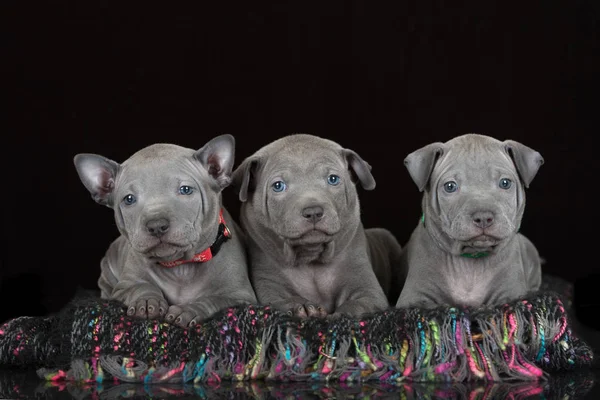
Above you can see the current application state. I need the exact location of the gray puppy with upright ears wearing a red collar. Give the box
[74,135,256,327]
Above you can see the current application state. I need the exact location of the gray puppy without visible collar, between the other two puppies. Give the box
[233,134,401,317]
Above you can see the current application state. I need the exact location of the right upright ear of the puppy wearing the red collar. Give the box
[194,135,235,190]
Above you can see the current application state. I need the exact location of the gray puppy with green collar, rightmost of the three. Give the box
[397,134,544,308]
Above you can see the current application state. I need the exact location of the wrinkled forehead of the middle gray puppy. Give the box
[263,147,345,175]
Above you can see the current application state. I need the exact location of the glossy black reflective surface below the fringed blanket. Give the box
[0,369,600,400]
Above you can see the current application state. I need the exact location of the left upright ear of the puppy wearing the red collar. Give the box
[73,154,120,206]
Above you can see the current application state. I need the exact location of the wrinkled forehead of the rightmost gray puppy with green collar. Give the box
[433,144,516,179]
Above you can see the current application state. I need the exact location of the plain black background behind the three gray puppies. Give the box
[0,0,600,320]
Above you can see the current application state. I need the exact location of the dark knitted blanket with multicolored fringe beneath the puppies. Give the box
[0,277,593,384]
